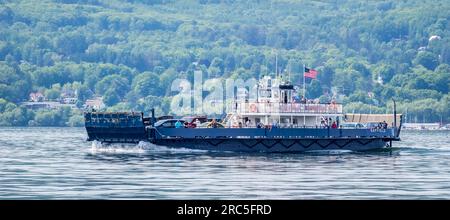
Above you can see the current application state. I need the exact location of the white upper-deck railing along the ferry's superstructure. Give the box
[233,102,342,114]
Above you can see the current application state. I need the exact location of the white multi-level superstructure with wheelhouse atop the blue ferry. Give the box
[225,76,343,127]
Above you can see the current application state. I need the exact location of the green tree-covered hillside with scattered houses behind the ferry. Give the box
[0,0,450,126]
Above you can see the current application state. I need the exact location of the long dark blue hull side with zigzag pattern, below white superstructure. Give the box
[149,128,399,152]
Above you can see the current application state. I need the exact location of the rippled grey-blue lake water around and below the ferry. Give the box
[0,128,450,199]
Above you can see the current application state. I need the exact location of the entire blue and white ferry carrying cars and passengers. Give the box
[84,76,402,152]
